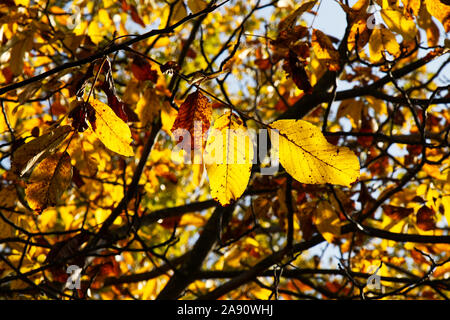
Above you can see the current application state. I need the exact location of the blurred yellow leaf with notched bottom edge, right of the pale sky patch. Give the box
[369,28,400,63]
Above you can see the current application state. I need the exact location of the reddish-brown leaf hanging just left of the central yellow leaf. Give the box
[172,90,212,150]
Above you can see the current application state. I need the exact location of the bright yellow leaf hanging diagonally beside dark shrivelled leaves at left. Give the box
[90,99,134,157]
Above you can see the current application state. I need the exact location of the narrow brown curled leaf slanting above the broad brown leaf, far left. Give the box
[12,125,72,176]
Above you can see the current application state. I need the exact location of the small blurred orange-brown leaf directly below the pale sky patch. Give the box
[311,29,340,71]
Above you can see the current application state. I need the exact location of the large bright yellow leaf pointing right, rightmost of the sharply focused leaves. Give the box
[270,120,359,186]
